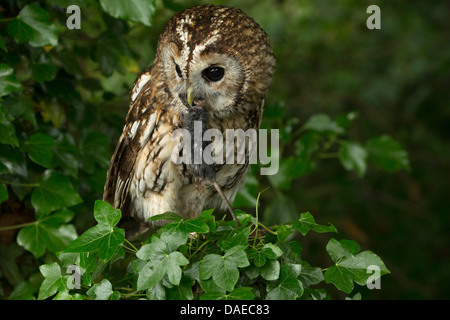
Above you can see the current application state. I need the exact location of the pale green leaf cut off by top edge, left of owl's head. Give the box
[100,0,155,26]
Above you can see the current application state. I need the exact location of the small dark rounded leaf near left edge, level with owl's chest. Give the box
[24,132,55,168]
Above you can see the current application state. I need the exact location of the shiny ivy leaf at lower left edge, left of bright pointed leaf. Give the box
[17,210,77,258]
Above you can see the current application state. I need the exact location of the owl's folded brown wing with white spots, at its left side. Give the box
[103,67,157,218]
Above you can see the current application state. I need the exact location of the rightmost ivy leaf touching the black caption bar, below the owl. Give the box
[266,264,303,300]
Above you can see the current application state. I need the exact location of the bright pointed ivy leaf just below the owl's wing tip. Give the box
[64,200,125,262]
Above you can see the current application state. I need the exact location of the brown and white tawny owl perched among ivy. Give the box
[103,5,275,237]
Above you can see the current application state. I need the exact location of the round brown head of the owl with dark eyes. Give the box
[154,5,275,118]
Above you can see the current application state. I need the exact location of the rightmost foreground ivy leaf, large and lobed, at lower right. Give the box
[325,238,389,293]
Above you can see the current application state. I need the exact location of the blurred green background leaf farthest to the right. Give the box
[366,135,410,172]
